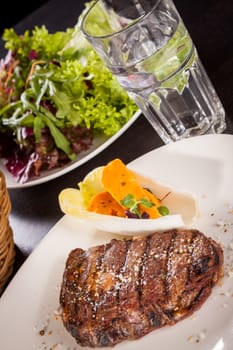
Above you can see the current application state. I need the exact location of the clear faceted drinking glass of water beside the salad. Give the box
[81,0,226,143]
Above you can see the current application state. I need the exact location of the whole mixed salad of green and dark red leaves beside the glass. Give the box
[0,6,138,183]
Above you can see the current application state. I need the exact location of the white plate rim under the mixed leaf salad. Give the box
[0,111,141,189]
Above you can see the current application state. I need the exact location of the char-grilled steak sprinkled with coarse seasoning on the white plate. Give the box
[60,229,223,347]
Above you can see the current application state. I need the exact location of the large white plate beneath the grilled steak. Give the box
[0,135,233,350]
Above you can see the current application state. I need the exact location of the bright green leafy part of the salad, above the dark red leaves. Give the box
[0,8,138,158]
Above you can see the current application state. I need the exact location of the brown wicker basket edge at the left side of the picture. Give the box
[0,171,15,293]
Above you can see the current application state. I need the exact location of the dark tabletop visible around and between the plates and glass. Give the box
[0,0,233,292]
